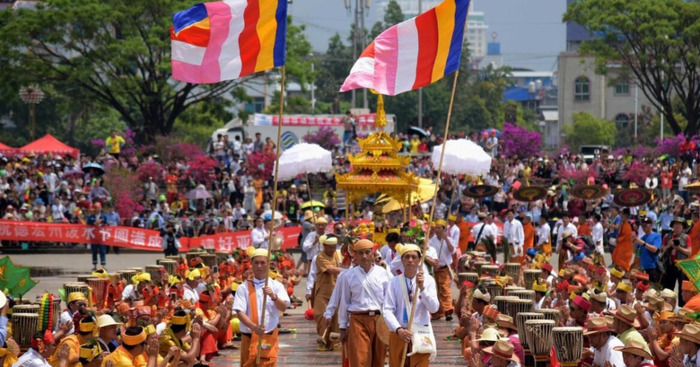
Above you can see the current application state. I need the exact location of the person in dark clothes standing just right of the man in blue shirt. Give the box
[659,217,692,305]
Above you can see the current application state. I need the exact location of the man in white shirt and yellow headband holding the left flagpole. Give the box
[233,248,291,366]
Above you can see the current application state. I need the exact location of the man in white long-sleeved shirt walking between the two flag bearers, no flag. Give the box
[337,239,389,366]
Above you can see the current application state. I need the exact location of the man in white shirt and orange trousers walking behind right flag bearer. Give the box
[426,219,457,321]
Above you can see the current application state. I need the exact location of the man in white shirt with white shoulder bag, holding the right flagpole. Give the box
[382,244,440,366]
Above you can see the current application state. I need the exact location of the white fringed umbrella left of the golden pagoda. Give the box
[277,143,333,181]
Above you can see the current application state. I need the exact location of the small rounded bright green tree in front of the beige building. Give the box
[564,112,617,151]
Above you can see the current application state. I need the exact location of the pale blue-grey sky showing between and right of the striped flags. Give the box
[289,0,566,71]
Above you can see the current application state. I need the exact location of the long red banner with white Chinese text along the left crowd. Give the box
[0,220,301,252]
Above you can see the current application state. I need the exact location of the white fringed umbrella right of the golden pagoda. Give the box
[430,139,491,176]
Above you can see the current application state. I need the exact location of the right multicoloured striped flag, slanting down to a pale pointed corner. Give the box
[340,0,469,96]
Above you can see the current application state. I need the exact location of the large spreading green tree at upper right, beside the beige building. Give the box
[564,0,700,136]
